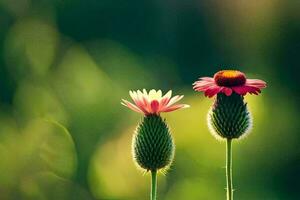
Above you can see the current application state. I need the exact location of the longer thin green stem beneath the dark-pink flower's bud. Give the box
[226,139,233,200]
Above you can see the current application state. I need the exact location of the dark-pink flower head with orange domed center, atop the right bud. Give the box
[193,70,266,98]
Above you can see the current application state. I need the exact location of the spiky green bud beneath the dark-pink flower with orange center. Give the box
[208,93,252,139]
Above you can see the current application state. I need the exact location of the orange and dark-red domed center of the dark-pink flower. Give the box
[214,70,246,87]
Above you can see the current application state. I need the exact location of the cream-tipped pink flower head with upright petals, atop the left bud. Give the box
[121,89,189,115]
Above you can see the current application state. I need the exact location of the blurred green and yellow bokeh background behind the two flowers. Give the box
[0,0,300,200]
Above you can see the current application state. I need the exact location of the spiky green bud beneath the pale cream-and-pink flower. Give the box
[132,115,175,171]
